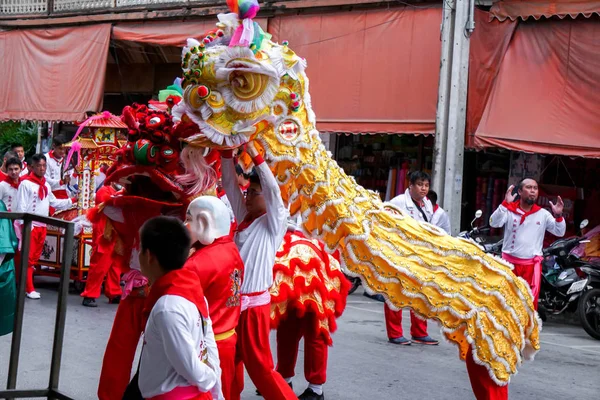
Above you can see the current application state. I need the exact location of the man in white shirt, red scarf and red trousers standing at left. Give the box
[14,154,73,300]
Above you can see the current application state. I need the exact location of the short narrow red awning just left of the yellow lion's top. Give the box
[112,16,267,47]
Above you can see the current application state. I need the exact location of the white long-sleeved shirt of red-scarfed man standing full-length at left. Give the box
[14,181,73,227]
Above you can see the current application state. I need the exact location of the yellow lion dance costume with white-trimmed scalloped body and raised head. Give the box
[173,3,540,385]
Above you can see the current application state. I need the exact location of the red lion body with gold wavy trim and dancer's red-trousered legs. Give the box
[270,223,350,400]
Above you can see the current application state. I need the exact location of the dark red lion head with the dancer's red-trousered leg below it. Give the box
[98,104,214,400]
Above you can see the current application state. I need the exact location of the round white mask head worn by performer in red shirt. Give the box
[186,196,231,246]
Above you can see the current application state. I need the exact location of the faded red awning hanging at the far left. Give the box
[0,24,110,121]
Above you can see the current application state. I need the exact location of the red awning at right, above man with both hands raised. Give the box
[474,19,600,157]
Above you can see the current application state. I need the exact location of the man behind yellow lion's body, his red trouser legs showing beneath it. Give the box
[384,171,439,345]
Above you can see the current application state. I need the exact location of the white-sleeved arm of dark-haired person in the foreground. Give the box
[154,311,217,392]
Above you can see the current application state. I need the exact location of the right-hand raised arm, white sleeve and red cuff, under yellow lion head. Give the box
[247,143,289,235]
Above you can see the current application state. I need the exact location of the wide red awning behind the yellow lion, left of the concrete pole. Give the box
[269,7,441,134]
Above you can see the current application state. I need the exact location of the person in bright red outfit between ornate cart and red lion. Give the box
[81,183,121,307]
